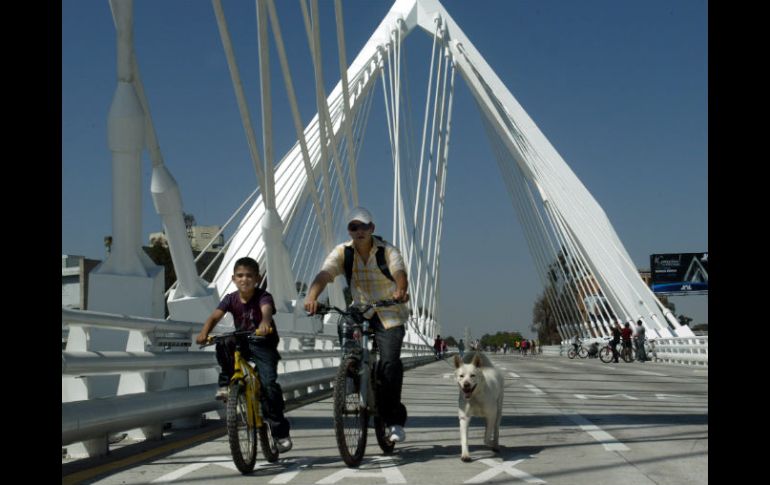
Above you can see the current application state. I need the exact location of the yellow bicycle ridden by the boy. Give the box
[200,329,279,475]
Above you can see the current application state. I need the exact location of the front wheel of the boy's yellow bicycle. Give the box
[227,382,257,475]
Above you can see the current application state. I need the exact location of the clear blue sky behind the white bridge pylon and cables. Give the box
[62,0,708,336]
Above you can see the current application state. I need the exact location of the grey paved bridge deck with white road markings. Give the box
[62,354,708,485]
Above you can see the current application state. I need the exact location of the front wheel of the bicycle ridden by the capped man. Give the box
[334,359,369,467]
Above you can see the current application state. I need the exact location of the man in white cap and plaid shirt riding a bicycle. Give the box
[305,207,409,441]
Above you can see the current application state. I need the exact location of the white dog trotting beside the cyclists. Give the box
[454,352,505,461]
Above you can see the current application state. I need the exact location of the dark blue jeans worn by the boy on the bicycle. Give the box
[216,338,291,439]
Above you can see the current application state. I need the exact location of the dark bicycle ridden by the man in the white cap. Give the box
[316,300,399,467]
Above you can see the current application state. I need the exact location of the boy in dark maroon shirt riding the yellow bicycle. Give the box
[195,257,292,453]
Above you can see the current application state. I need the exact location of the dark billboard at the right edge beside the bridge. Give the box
[650,253,709,293]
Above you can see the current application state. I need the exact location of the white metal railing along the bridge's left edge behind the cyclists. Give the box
[62,308,433,446]
